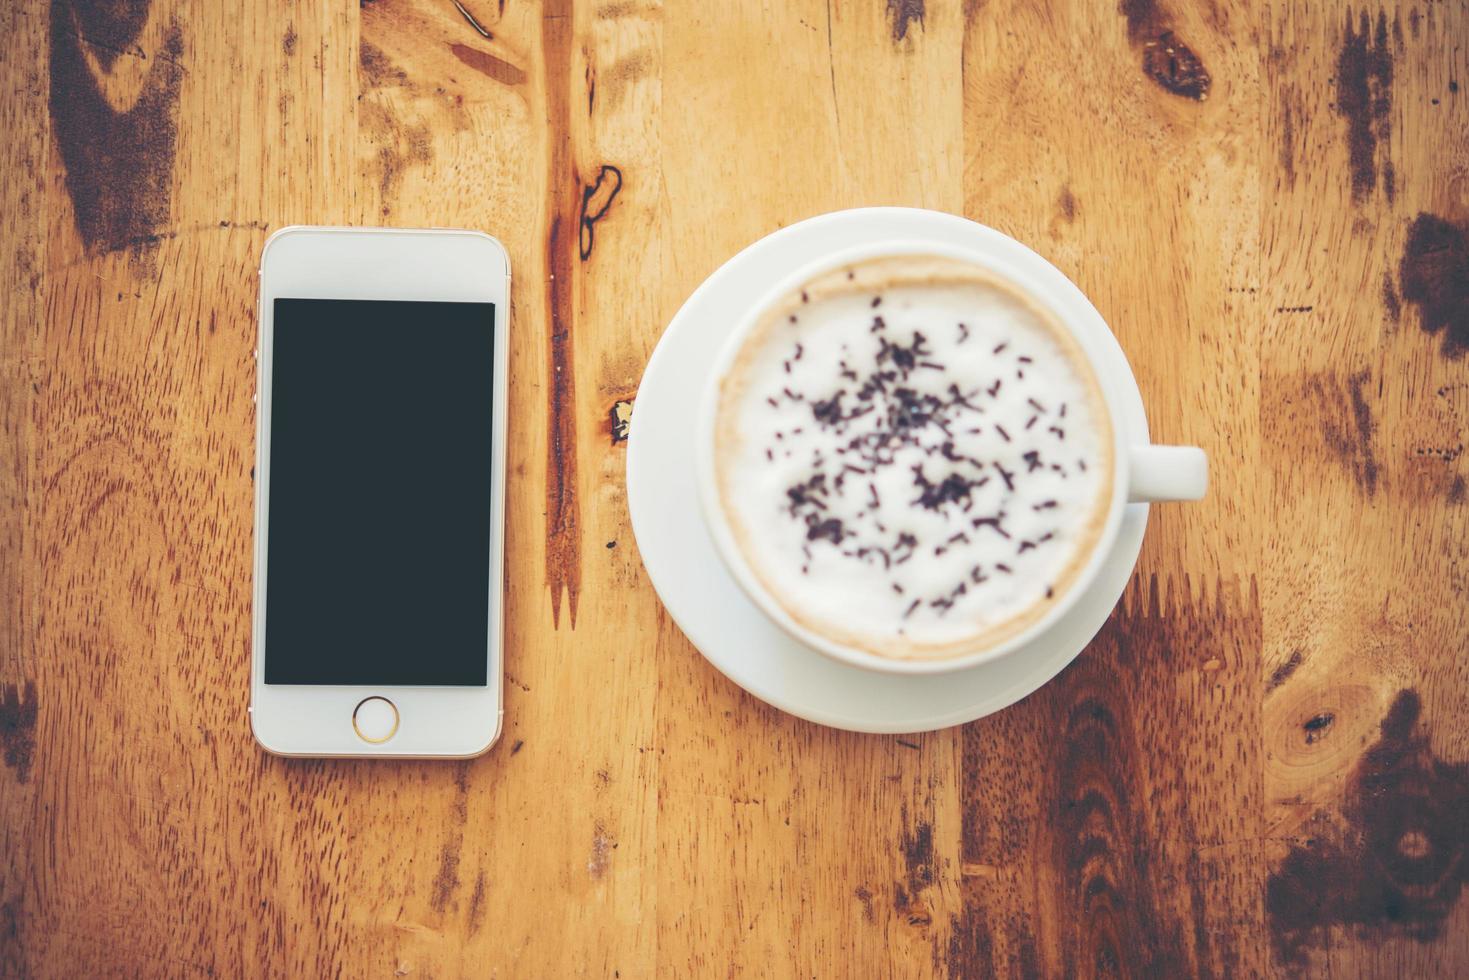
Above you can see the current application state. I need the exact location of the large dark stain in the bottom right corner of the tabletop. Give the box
[1265,688,1469,965]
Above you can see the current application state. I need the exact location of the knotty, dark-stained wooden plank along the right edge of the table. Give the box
[1260,3,1469,977]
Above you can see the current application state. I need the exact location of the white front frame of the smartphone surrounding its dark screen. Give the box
[250,226,510,758]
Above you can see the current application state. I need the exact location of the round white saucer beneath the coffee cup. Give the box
[627,207,1147,735]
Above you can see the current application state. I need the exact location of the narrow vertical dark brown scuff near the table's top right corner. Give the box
[1335,10,1393,201]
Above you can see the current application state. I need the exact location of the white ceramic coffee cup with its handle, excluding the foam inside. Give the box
[695,241,1209,674]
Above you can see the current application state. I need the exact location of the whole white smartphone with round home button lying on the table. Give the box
[250,228,510,758]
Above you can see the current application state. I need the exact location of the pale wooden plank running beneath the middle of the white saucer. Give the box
[652,3,964,977]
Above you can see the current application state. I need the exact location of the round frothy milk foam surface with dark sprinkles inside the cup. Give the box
[715,259,1112,657]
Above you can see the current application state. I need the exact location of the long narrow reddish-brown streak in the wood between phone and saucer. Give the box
[541,0,585,629]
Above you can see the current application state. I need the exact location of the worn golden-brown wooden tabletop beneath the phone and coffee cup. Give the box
[0,0,1469,977]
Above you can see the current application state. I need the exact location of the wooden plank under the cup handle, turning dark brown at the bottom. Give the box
[949,3,1266,976]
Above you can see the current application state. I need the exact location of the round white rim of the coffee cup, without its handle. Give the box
[695,238,1130,674]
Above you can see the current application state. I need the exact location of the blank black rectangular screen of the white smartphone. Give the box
[264,300,498,686]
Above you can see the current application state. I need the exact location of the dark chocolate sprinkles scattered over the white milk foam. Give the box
[764,279,1086,632]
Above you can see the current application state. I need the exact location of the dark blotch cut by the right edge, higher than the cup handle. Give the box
[1397,213,1469,360]
